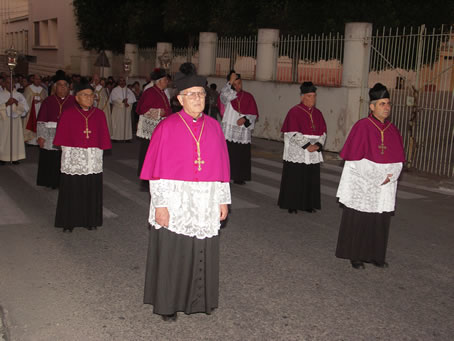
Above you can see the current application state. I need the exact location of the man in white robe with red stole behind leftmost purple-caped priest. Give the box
[23,75,47,146]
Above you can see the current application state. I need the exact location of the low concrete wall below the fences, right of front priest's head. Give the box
[208,77,350,152]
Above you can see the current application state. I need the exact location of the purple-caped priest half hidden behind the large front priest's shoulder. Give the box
[136,68,172,187]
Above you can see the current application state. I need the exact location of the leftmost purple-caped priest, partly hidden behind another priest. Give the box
[36,73,75,189]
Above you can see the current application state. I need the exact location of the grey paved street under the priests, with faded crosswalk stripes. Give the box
[0,139,454,341]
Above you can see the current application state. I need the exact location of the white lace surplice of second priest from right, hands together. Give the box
[283,131,326,165]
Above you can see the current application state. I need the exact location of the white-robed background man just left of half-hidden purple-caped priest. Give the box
[110,77,136,142]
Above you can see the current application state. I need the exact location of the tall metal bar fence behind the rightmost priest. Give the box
[369,26,454,176]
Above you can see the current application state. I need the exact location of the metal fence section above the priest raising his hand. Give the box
[215,36,257,79]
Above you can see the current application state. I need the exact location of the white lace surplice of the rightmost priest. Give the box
[336,159,402,213]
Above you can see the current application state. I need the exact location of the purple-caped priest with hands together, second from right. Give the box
[278,82,326,213]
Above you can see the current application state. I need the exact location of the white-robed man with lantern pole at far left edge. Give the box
[0,79,29,165]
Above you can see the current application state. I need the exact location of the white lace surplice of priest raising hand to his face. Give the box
[220,83,257,144]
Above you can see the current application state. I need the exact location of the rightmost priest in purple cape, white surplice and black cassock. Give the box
[336,83,405,269]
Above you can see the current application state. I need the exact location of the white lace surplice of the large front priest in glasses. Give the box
[148,179,231,239]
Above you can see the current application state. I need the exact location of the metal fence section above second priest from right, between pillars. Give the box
[275,33,344,86]
